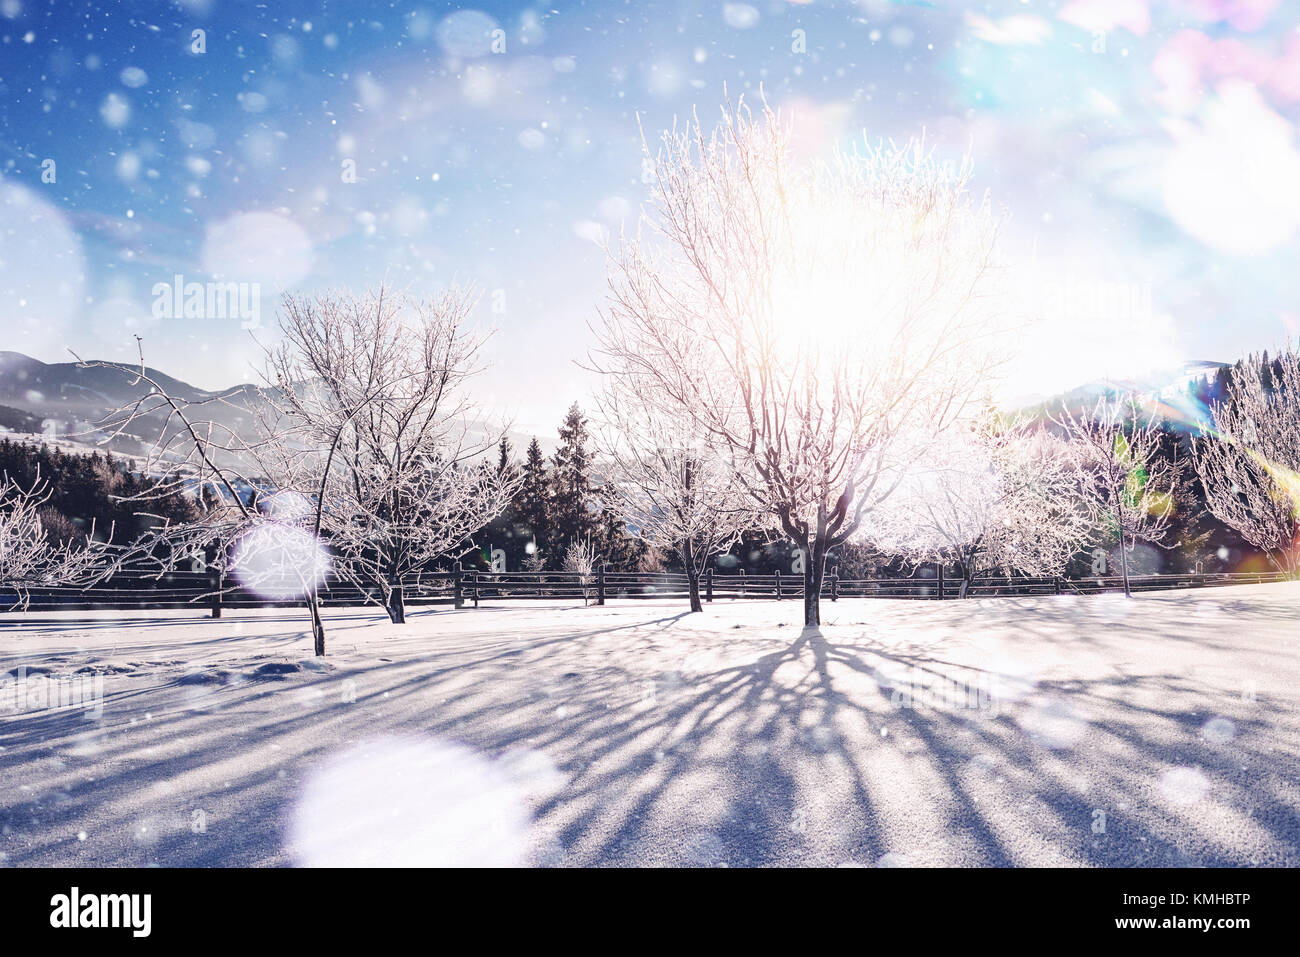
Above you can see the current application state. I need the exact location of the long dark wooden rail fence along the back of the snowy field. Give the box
[0,568,1287,618]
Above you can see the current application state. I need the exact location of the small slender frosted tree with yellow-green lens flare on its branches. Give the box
[1054,395,1183,597]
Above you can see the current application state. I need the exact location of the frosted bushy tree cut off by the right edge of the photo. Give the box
[1193,348,1300,575]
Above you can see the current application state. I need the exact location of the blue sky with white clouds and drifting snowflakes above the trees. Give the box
[0,0,1300,433]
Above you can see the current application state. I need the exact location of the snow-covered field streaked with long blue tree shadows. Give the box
[0,584,1300,866]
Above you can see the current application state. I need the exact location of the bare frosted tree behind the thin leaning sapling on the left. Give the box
[260,287,517,623]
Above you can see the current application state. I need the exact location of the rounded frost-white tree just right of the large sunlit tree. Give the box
[867,412,1092,598]
